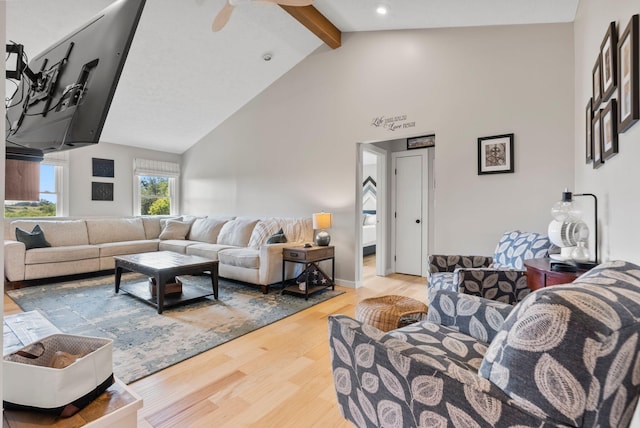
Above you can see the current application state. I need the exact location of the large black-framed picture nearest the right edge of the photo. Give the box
[618,14,640,133]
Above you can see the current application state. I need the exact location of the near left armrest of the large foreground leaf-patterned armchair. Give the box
[329,315,555,427]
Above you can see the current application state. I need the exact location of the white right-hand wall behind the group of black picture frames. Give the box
[574,0,640,263]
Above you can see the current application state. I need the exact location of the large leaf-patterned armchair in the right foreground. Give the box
[329,261,640,428]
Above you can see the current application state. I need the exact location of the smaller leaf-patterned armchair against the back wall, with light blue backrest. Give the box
[427,230,551,304]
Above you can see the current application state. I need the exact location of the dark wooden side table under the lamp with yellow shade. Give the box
[282,245,336,300]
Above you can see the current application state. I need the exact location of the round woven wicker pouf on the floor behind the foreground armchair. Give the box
[356,295,427,331]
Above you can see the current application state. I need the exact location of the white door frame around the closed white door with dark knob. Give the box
[390,149,431,277]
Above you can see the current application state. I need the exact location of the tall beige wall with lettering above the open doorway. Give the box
[183,24,574,283]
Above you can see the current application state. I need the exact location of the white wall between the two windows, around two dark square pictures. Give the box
[69,142,181,216]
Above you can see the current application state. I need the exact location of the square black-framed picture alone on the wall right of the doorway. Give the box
[478,134,515,175]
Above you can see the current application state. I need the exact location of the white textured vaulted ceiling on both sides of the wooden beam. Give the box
[6,0,578,153]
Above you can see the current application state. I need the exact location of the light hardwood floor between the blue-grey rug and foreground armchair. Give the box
[5,256,426,428]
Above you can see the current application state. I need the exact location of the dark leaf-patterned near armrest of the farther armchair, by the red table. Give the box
[453,268,531,305]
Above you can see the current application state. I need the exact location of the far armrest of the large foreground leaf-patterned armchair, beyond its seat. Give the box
[427,290,513,343]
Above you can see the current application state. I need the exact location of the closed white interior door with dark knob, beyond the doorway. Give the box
[394,155,426,275]
